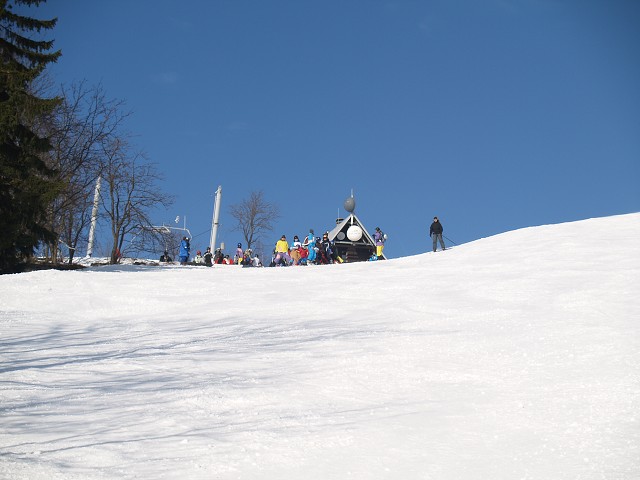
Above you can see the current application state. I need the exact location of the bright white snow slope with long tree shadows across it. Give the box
[0,214,640,480]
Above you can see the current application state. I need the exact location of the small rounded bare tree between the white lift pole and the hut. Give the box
[229,191,280,248]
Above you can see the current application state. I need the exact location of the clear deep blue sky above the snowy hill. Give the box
[30,0,640,257]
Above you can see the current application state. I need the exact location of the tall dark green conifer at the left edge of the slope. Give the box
[0,0,60,272]
